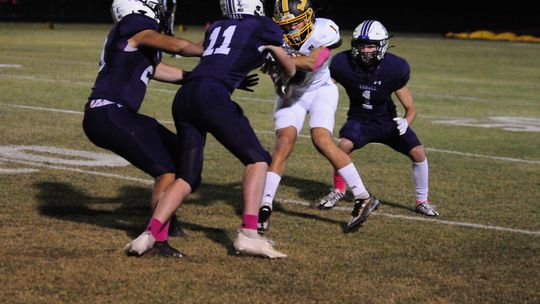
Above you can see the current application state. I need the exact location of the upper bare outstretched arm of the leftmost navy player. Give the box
[128,30,203,57]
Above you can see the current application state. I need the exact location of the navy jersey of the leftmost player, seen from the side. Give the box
[89,14,161,112]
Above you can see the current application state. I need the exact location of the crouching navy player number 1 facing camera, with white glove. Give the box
[321,20,439,216]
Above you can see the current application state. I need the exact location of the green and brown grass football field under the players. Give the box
[0,23,540,303]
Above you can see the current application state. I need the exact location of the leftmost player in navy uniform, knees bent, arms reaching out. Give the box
[83,0,202,247]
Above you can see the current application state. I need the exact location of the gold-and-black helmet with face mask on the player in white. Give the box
[274,0,314,48]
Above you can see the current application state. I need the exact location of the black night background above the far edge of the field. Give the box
[0,0,540,35]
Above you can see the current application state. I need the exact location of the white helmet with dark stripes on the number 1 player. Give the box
[351,20,389,67]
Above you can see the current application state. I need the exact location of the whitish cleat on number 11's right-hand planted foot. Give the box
[234,229,287,259]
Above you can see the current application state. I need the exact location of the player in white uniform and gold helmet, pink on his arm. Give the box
[258,0,379,233]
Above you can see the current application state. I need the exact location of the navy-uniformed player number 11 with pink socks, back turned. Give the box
[126,0,296,258]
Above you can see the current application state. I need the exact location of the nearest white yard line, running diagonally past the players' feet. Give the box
[0,157,540,235]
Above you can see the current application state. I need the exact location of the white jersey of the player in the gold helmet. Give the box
[292,18,340,97]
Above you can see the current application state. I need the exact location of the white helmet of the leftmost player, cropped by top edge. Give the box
[111,0,167,25]
